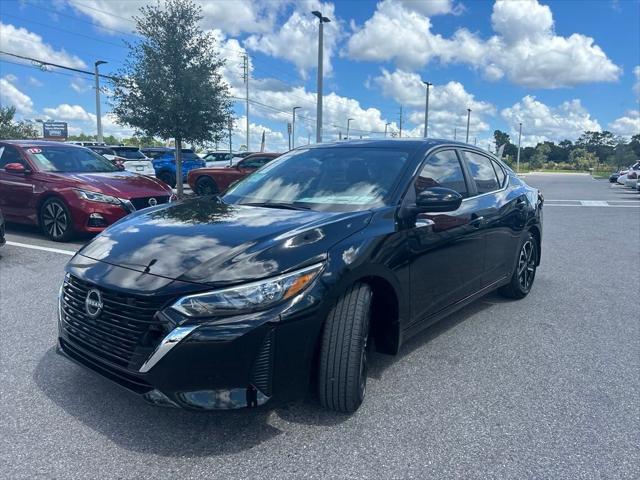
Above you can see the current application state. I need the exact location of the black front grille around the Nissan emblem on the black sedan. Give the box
[61,276,166,370]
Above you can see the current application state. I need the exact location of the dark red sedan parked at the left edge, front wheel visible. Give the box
[0,140,172,242]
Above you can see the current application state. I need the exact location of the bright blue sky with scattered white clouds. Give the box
[0,0,640,149]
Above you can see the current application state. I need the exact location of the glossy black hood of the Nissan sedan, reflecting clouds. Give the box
[79,197,371,286]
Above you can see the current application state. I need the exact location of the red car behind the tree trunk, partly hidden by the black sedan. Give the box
[187,153,282,195]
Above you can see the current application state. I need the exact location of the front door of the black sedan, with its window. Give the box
[405,148,484,323]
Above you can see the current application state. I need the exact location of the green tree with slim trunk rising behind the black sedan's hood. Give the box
[113,0,231,197]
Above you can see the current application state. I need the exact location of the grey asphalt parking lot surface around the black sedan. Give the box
[0,174,640,479]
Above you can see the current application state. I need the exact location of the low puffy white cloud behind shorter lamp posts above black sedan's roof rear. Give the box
[373,69,496,138]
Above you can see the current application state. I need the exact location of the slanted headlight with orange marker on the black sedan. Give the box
[171,263,323,318]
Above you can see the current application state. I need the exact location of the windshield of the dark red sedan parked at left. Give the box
[26,146,118,173]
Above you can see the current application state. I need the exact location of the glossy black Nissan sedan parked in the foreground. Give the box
[58,140,543,412]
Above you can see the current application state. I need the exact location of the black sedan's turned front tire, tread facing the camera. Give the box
[318,283,372,413]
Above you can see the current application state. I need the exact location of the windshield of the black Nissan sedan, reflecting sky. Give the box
[224,147,411,211]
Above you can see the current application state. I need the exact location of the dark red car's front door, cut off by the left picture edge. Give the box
[0,144,33,222]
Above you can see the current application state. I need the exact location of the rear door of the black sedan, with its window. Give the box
[462,149,528,287]
